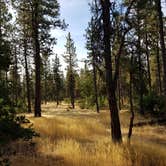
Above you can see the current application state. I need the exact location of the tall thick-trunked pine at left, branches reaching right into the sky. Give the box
[13,0,66,117]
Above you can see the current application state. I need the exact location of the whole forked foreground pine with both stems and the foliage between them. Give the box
[100,0,135,142]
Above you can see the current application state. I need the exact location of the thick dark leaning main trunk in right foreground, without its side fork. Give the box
[101,0,122,142]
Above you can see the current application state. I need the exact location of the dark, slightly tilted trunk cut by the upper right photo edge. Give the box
[156,0,166,96]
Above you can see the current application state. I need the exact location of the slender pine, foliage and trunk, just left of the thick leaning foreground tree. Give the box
[86,0,103,113]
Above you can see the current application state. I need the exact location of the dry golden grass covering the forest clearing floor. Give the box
[10,103,166,166]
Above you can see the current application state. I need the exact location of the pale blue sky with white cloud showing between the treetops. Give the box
[52,0,91,69]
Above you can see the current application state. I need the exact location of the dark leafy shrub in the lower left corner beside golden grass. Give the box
[0,99,38,144]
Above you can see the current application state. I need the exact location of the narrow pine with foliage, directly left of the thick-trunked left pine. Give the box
[13,0,33,113]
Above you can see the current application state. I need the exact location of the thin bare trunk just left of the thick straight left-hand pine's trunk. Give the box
[24,39,32,113]
